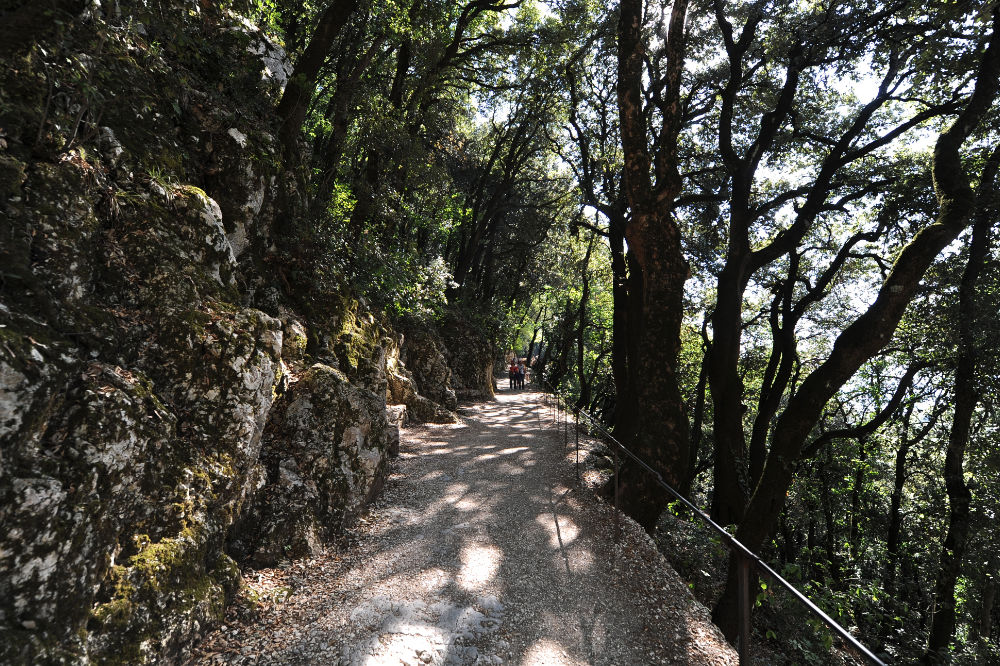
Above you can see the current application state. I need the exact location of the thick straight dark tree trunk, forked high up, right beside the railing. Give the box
[615,0,688,529]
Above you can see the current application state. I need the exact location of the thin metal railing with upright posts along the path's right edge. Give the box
[538,380,886,666]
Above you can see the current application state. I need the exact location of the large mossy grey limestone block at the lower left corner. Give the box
[0,304,281,663]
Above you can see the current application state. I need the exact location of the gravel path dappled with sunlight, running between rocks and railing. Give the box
[191,391,738,666]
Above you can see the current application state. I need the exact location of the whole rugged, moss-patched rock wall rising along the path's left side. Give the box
[0,2,458,664]
